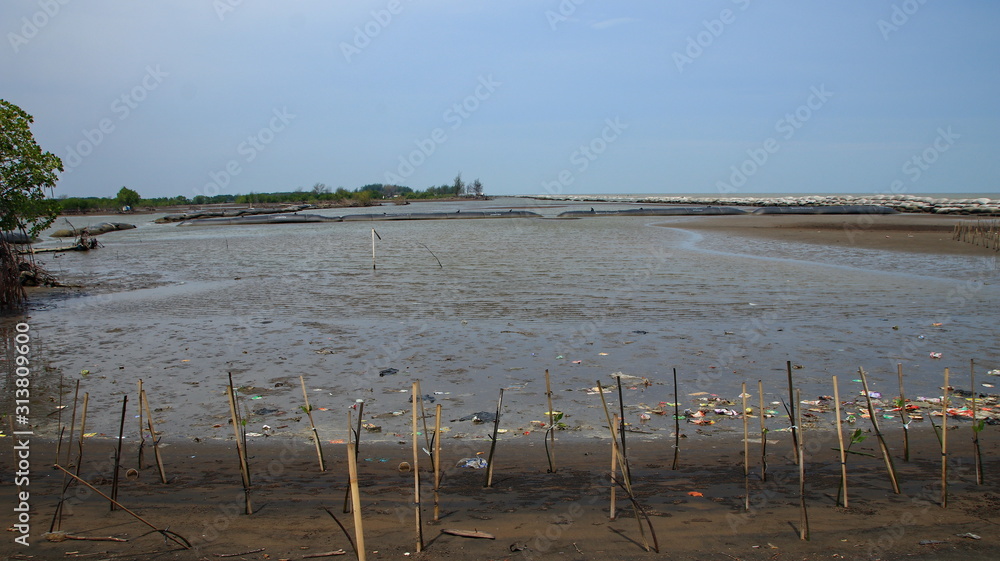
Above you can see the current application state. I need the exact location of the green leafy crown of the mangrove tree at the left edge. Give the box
[0,99,63,237]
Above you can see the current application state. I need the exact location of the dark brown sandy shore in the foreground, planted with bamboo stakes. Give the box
[0,426,1000,560]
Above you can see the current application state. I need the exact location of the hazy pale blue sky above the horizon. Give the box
[0,0,1000,197]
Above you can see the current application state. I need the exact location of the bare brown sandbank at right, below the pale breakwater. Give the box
[679,214,997,257]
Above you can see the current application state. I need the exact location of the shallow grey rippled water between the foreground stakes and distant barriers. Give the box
[5,200,1000,440]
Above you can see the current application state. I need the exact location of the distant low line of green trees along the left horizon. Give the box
[56,174,484,213]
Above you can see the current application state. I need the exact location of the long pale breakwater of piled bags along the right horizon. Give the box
[531,195,1000,216]
